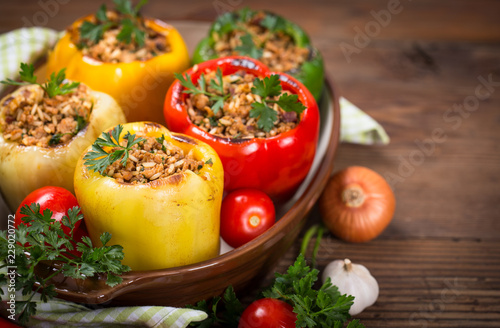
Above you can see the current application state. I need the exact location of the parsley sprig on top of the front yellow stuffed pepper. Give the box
[83,124,146,175]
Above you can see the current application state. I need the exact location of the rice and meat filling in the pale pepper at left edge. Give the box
[0,84,94,147]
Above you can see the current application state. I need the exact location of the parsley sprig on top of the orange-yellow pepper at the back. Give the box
[80,0,148,48]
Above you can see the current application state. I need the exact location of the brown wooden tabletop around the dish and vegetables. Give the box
[0,0,500,328]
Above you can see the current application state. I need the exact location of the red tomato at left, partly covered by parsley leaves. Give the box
[14,186,88,256]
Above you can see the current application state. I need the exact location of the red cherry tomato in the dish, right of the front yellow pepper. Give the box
[220,188,276,248]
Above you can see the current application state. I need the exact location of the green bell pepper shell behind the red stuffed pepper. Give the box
[192,8,325,100]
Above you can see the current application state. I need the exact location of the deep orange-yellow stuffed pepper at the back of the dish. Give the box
[47,2,190,123]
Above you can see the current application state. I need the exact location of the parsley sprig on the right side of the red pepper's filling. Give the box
[250,74,306,132]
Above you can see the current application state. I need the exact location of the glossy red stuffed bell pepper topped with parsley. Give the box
[164,57,319,201]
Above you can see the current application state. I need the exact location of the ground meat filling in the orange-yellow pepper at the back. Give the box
[76,11,170,63]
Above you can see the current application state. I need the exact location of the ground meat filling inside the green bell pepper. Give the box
[212,12,310,72]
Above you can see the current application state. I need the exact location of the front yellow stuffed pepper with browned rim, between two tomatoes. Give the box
[75,122,224,270]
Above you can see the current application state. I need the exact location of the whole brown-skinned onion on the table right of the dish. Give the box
[319,166,396,243]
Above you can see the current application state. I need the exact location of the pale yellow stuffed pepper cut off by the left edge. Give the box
[0,64,125,211]
